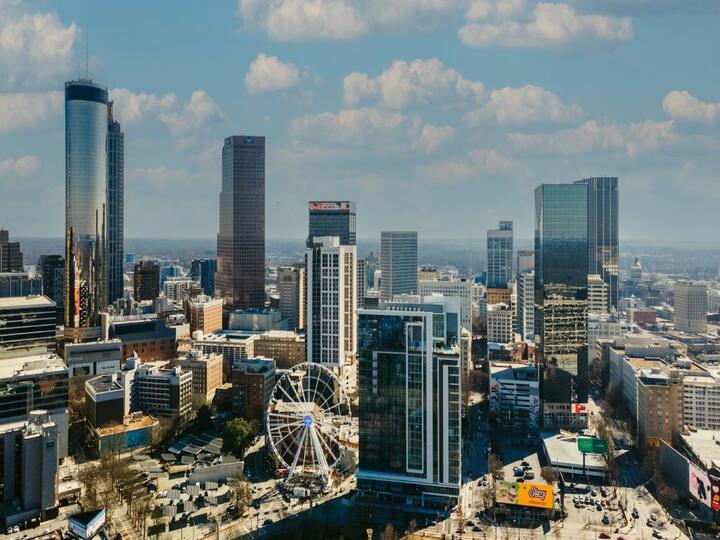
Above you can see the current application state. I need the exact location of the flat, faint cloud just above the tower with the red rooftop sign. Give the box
[290,108,454,152]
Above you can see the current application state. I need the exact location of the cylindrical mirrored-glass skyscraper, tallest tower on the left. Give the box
[65,79,108,341]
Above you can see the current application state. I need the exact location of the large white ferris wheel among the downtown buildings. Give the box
[266,363,352,485]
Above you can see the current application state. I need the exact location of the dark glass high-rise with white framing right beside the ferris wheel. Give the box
[357,301,462,509]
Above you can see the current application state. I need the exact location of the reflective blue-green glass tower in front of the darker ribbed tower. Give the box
[535,184,588,428]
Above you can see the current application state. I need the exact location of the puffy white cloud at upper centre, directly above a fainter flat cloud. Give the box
[343,58,484,109]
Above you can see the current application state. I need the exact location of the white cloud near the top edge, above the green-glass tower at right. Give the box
[458,0,633,48]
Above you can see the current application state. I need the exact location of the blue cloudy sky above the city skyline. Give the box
[0,0,720,243]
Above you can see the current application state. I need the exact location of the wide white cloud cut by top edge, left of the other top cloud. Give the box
[238,0,467,41]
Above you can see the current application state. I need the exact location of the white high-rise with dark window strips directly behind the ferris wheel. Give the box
[305,236,357,367]
